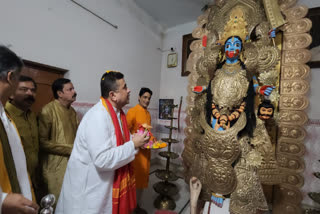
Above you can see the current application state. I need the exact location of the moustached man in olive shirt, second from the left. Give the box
[5,75,39,199]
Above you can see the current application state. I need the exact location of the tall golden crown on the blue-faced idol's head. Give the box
[218,7,248,45]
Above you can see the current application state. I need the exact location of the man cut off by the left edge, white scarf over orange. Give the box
[0,46,38,214]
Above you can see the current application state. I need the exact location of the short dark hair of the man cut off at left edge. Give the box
[0,45,23,80]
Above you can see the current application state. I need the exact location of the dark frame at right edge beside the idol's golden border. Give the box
[307,7,320,68]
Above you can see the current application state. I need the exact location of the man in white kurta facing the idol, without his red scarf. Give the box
[55,71,148,214]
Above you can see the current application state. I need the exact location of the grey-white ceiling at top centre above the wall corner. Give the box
[134,0,211,28]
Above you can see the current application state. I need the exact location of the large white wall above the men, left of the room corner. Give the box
[0,0,162,106]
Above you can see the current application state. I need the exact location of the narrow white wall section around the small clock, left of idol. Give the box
[160,22,197,109]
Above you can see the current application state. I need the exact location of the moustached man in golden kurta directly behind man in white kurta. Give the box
[39,78,79,201]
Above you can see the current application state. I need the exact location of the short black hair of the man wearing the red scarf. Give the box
[100,71,124,98]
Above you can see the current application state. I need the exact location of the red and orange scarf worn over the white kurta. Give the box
[101,98,136,214]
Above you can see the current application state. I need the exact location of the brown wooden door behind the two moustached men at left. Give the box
[21,60,68,114]
